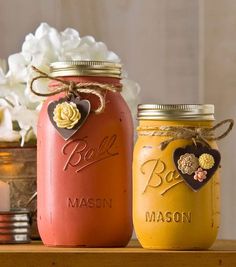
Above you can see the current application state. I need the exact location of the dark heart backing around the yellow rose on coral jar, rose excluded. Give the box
[48,97,91,140]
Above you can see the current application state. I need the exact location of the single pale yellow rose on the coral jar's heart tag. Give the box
[53,102,81,129]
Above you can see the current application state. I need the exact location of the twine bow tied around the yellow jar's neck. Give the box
[138,119,234,150]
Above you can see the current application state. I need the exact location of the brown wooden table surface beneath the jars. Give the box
[0,240,236,267]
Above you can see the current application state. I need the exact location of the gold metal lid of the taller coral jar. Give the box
[50,60,121,79]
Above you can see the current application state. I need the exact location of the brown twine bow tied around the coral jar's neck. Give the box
[30,66,122,114]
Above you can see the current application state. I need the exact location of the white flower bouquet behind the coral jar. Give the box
[0,23,140,146]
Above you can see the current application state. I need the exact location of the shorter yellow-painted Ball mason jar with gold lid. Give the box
[133,104,220,250]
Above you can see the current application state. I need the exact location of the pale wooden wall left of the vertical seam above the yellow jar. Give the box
[0,0,199,103]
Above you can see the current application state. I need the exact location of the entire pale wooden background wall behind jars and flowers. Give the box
[0,0,236,239]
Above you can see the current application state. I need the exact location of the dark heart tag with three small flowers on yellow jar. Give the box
[174,143,221,191]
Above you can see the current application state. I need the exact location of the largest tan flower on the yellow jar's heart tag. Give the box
[178,153,199,175]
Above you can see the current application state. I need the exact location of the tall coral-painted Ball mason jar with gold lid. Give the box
[37,61,133,247]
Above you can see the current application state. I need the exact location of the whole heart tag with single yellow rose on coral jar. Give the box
[48,97,91,140]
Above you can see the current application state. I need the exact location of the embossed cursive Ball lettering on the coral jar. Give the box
[62,134,119,172]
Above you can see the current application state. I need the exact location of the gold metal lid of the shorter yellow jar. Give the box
[138,104,214,121]
